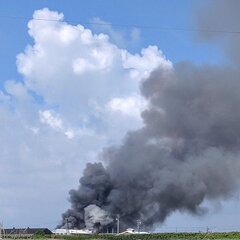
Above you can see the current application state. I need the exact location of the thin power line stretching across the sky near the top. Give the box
[0,15,240,34]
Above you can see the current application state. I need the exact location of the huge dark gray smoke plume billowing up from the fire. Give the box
[61,0,240,232]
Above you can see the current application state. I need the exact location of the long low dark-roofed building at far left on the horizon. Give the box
[2,228,52,238]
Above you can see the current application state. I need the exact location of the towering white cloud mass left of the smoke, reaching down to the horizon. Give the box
[0,9,171,226]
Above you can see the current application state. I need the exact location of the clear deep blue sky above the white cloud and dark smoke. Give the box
[0,0,223,84]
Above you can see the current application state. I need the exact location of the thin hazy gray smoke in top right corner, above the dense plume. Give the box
[198,0,240,65]
